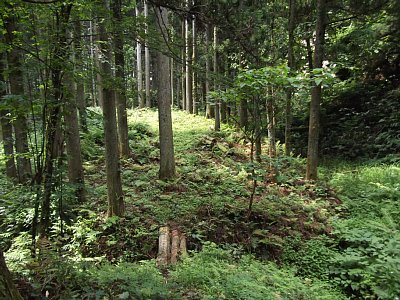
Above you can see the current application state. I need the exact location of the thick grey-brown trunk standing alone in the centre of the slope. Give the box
[156,7,175,179]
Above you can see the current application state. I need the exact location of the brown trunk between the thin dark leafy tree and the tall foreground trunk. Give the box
[63,73,85,202]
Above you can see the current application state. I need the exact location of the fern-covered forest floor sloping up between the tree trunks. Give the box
[0,109,400,299]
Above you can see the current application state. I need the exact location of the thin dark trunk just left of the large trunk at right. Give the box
[285,0,296,156]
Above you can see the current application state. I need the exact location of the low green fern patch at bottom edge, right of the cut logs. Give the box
[170,244,344,300]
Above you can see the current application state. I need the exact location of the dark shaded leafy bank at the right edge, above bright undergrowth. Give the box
[321,82,400,158]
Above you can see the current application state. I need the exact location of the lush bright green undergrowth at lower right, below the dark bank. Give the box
[332,166,400,299]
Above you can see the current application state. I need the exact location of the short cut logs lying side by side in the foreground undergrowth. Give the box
[157,226,187,266]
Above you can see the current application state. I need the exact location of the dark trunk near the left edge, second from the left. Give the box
[4,16,32,183]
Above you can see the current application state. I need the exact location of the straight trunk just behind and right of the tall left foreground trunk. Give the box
[112,0,130,157]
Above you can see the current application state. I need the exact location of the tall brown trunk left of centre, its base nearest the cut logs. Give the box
[99,0,125,217]
